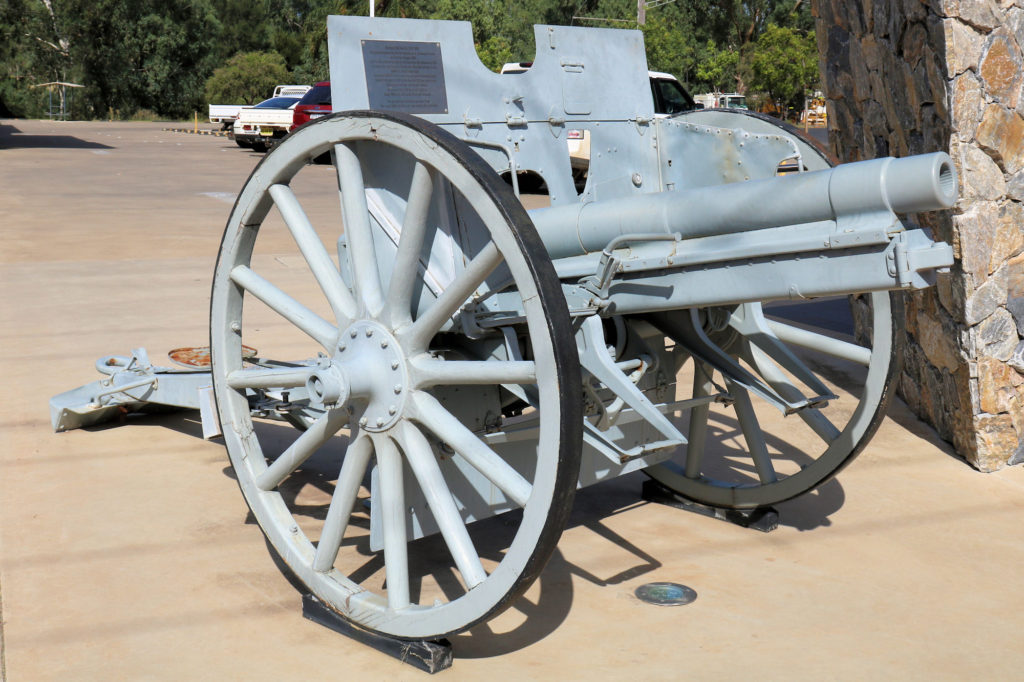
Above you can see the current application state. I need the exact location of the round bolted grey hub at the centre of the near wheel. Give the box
[306,319,410,432]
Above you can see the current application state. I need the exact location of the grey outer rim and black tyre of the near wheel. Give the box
[211,112,581,638]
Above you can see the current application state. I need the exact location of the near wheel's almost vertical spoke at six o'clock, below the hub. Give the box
[373,434,409,610]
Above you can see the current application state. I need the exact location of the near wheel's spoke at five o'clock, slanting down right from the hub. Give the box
[399,422,487,589]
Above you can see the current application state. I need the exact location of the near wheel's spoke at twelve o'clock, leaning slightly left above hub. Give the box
[334,143,383,314]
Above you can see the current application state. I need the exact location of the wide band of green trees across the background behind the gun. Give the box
[0,0,817,117]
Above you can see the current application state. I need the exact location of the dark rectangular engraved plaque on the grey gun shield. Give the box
[362,40,447,114]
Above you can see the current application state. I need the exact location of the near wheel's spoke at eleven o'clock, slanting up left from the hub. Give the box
[269,184,357,328]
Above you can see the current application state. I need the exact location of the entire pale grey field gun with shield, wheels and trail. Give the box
[51,17,957,639]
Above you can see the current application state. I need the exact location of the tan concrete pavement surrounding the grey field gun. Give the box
[0,121,1024,682]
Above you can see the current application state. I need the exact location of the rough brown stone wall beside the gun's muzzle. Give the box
[813,0,1024,471]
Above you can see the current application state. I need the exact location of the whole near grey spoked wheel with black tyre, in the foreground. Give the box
[211,112,582,638]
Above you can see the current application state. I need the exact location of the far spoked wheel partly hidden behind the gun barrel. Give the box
[646,110,903,509]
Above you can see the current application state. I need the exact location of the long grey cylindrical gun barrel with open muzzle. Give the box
[530,152,957,259]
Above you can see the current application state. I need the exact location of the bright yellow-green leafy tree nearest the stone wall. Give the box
[750,24,818,109]
